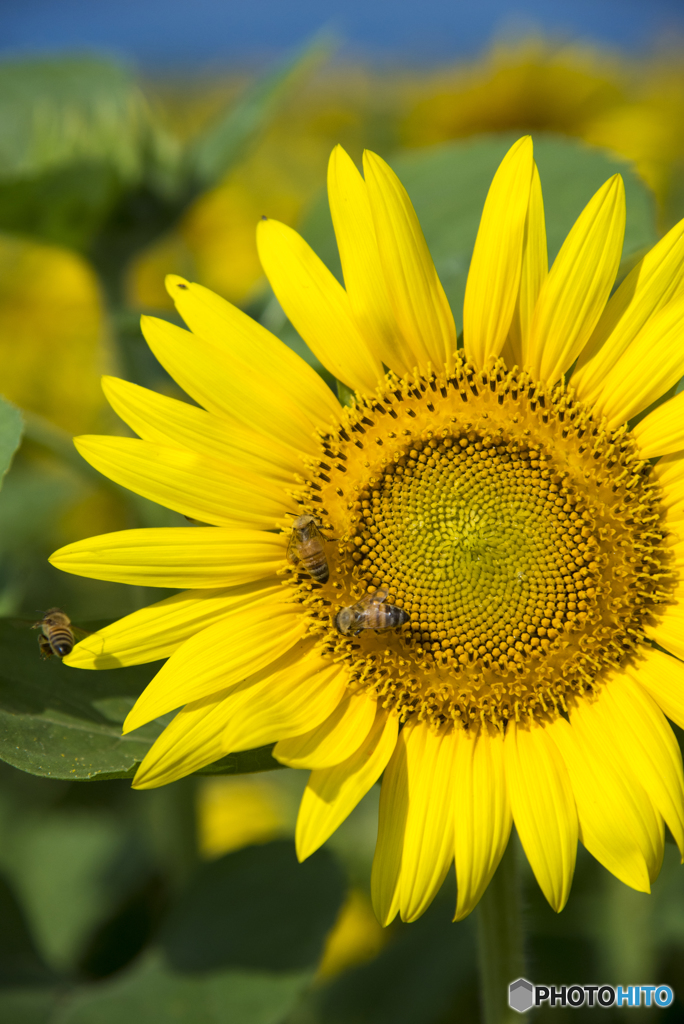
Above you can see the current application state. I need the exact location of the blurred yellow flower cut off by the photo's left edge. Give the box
[0,234,109,433]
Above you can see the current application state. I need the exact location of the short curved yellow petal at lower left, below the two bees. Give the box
[273,693,376,769]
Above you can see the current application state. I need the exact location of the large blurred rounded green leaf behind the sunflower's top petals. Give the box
[302,133,657,331]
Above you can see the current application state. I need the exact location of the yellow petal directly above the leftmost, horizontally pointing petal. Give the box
[74,435,297,529]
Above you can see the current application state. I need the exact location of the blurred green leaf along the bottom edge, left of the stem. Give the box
[56,954,311,1024]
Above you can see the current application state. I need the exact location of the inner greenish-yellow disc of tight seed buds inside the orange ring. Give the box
[352,429,589,668]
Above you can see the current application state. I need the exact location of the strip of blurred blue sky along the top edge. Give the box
[0,0,684,71]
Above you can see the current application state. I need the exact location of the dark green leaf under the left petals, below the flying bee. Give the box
[0,618,282,779]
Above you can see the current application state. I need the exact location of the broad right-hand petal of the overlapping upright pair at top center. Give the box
[364,151,457,373]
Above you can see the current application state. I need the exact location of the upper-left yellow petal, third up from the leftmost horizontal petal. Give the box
[140,313,327,454]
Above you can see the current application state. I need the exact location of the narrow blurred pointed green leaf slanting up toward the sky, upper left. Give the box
[187,39,330,187]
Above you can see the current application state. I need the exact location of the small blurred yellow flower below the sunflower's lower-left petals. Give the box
[199,776,287,857]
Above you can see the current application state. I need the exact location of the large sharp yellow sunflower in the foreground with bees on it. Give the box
[52,138,684,924]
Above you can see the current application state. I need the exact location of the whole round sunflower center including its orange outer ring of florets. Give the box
[291,362,672,723]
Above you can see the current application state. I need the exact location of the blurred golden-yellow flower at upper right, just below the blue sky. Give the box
[401,40,684,227]
